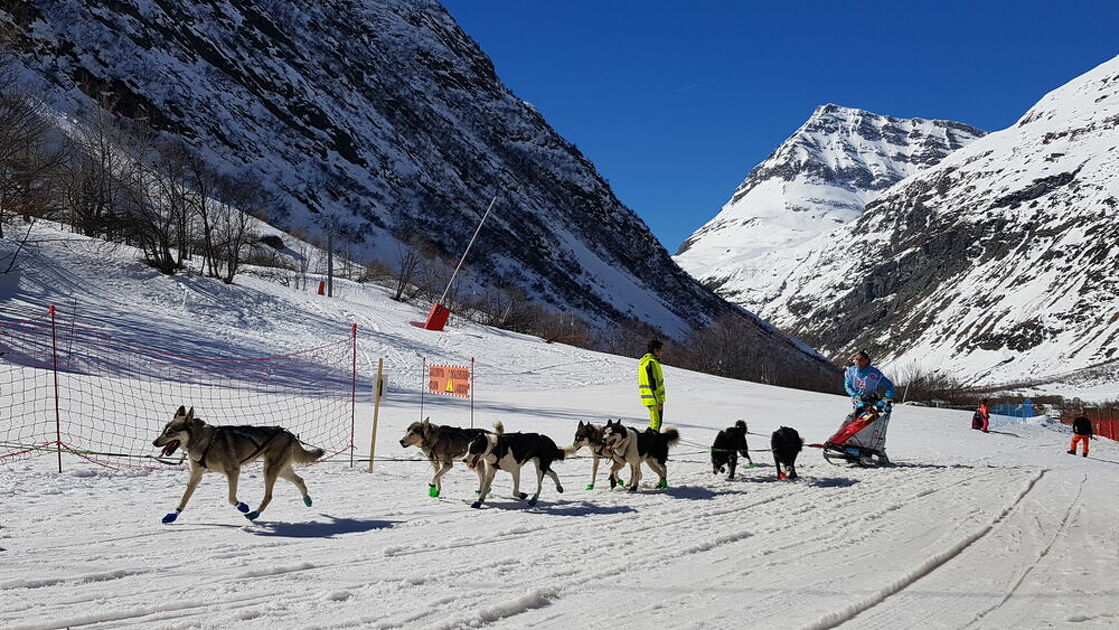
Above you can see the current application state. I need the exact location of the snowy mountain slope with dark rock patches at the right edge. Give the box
[761,57,1119,384]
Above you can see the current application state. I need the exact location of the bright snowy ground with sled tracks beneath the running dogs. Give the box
[0,223,1119,628]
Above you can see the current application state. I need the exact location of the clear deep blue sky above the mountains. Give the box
[442,0,1119,253]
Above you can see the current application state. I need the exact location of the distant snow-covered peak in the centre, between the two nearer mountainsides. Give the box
[676,104,984,312]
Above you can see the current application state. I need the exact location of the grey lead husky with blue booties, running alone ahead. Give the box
[152,406,323,523]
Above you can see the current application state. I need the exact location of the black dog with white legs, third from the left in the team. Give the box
[462,423,566,508]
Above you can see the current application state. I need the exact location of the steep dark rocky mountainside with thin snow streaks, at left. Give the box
[0,0,820,380]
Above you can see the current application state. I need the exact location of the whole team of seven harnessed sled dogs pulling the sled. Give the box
[152,406,803,524]
